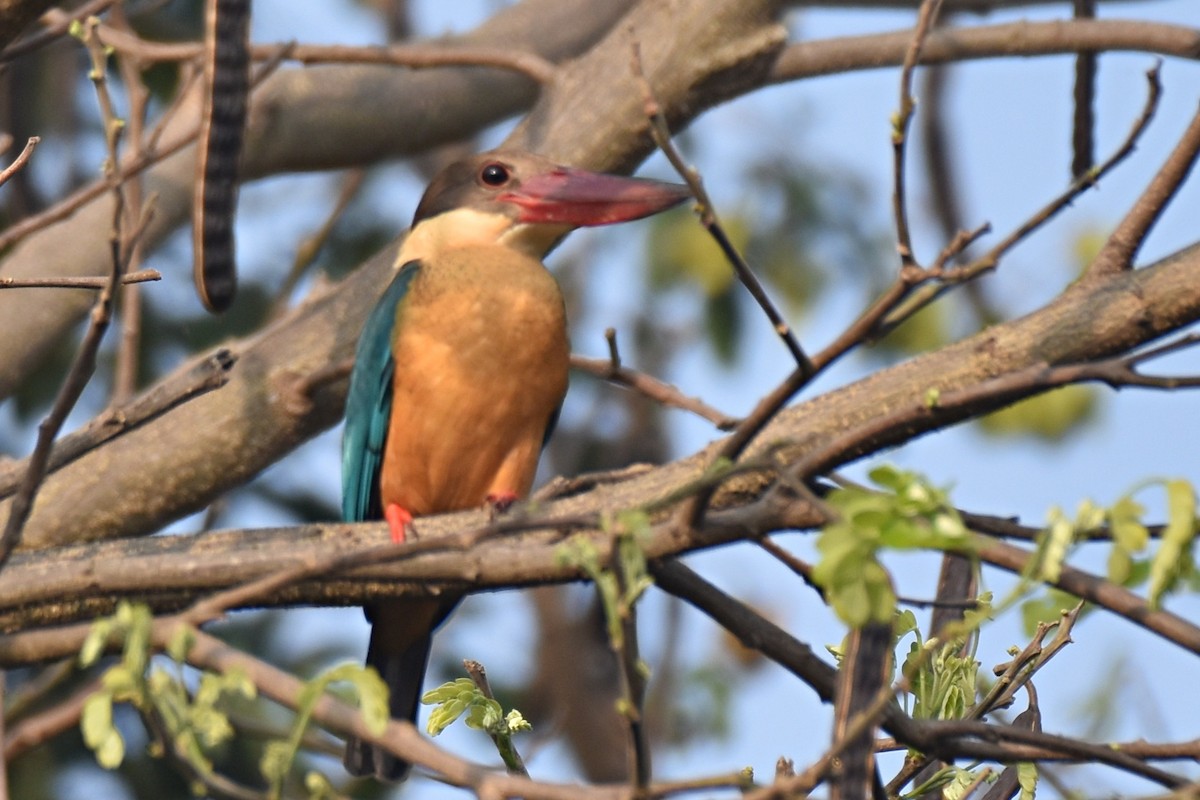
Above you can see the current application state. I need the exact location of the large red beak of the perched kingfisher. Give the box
[499,167,691,225]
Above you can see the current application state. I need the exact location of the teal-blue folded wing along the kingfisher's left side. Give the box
[342,261,420,522]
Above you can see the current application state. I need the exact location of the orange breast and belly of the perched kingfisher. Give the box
[380,247,569,516]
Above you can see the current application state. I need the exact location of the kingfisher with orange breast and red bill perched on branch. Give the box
[342,151,688,781]
